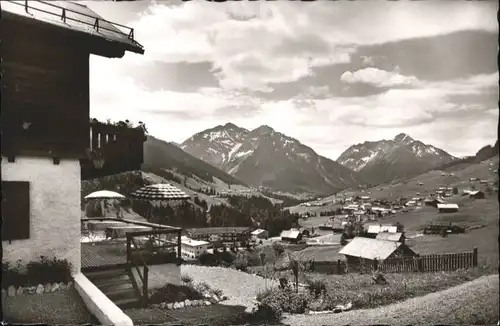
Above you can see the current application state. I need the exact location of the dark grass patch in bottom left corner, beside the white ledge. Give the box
[2,289,99,325]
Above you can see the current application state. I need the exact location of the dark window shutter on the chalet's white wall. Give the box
[2,181,30,240]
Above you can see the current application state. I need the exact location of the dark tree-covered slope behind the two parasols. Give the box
[81,171,296,230]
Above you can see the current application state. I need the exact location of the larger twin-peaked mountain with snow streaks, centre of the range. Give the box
[181,123,361,194]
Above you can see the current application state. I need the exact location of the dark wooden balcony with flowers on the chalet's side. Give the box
[80,121,146,180]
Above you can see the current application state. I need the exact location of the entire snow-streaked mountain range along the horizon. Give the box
[143,123,498,195]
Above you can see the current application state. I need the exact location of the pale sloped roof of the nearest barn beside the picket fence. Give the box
[339,237,402,260]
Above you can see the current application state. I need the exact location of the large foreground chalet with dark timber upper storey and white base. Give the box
[0,1,144,274]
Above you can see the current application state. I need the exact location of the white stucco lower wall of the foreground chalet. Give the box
[2,157,81,274]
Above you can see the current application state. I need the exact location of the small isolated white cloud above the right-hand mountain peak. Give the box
[340,67,417,87]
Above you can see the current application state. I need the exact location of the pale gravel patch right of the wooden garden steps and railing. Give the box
[181,265,277,309]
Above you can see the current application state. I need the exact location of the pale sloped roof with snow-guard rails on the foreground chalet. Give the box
[0,1,144,54]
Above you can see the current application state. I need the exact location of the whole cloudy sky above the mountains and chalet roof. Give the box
[85,1,499,159]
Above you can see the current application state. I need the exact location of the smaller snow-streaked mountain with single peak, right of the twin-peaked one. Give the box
[337,134,457,184]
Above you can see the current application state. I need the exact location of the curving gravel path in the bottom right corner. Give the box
[283,274,499,326]
